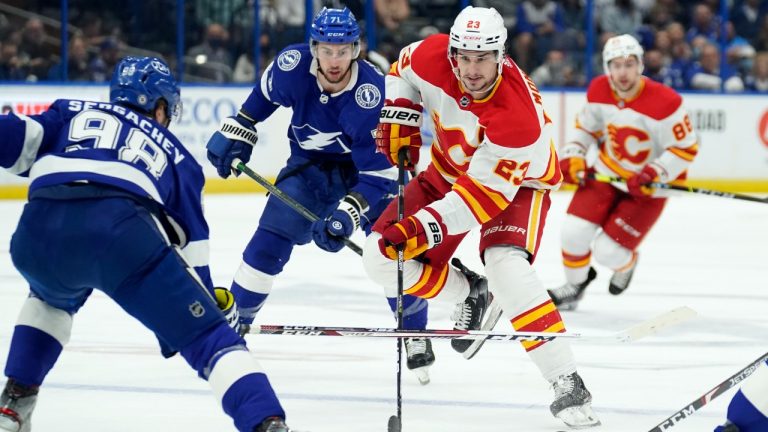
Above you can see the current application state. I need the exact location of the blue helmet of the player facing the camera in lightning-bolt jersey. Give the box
[309,7,360,58]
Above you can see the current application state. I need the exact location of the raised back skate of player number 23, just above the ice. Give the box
[451,258,502,360]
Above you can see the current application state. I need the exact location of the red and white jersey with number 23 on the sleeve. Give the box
[386,34,562,234]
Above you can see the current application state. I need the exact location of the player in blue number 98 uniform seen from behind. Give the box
[0,57,289,432]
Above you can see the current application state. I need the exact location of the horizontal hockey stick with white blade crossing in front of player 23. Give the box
[249,306,696,343]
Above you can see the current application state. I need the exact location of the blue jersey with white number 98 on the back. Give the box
[0,99,213,289]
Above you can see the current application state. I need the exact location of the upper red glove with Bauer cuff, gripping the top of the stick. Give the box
[376,98,422,171]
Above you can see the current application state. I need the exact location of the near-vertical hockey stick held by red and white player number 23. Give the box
[387,148,408,432]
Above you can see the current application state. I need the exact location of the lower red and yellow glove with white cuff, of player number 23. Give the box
[379,207,447,260]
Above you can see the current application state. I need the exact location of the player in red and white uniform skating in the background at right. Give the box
[549,35,699,310]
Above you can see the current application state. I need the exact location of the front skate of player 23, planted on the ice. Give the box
[549,372,600,429]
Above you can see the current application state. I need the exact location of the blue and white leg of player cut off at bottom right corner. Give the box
[715,361,768,432]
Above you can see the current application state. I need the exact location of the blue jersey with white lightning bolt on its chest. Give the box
[241,43,397,219]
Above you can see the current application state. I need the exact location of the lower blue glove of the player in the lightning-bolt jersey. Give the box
[312,192,368,252]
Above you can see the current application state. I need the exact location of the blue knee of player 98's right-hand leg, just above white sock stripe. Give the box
[179,320,247,379]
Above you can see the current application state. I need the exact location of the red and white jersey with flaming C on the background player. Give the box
[561,75,699,183]
